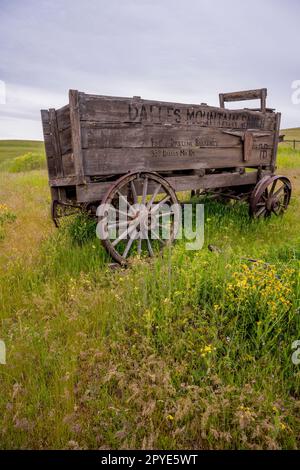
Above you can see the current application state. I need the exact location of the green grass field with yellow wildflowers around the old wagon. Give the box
[0,133,300,449]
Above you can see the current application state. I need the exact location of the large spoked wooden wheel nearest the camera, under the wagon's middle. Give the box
[97,172,179,265]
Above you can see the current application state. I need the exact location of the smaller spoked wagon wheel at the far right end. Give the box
[250,176,292,218]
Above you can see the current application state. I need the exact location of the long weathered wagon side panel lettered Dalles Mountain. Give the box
[79,93,275,176]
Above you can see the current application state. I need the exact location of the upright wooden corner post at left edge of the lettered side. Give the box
[69,90,85,184]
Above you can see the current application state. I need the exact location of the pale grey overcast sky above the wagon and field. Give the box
[0,0,300,139]
